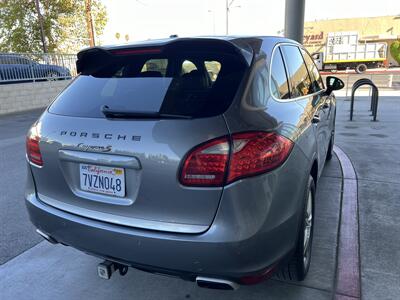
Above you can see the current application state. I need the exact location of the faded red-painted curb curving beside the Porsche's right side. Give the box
[334,146,361,299]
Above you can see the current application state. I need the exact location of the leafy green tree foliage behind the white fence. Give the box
[0,0,107,53]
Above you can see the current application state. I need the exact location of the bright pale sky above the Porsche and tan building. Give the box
[99,0,400,44]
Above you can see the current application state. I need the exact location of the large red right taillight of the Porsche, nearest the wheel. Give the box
[180,131,293,186]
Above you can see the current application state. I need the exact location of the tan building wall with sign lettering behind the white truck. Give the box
[304,16,400,65]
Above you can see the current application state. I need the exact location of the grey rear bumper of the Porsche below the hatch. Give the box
[26,194,296,282]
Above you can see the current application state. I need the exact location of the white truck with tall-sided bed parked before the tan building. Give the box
[312,31,387,74]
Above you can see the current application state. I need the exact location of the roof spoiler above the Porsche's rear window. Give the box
[76,38,254,75]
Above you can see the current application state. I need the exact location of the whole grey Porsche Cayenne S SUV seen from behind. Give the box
[25,37,343,289]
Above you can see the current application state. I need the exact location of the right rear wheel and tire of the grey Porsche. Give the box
[276,175,315,281]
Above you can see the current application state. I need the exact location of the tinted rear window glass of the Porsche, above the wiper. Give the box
[49,50,246,118]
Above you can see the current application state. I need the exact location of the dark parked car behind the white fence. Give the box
[0,54,71,82]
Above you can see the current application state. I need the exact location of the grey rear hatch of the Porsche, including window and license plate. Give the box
[31,39,248,233]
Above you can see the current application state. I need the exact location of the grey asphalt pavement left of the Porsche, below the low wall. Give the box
[0,110,42,264]
